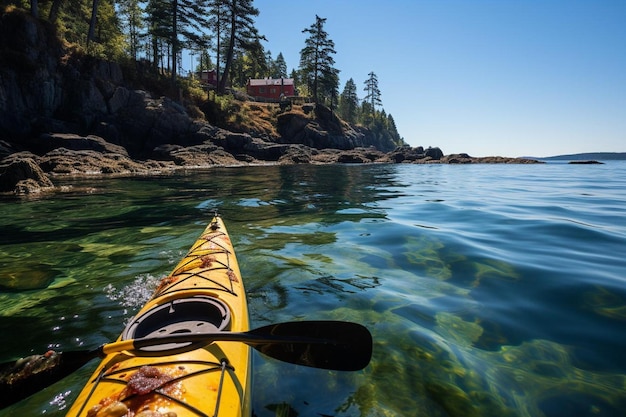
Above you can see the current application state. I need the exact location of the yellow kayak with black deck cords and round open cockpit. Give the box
[67,215,251,417]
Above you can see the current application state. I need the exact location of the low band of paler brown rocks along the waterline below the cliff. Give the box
[0,132,540,195]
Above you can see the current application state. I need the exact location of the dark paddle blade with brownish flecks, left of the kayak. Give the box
[0,350,98,409]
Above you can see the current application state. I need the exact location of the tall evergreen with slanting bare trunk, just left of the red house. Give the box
[218,0,265,94]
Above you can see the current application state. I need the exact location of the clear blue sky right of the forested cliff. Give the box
[254,0,626,156]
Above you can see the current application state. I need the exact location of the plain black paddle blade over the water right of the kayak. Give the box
[247,321,372,371]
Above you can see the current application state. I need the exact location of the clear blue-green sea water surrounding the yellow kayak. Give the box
[0,162,626,417]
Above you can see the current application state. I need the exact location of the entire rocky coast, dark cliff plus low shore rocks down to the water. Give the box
[0,13,539,195]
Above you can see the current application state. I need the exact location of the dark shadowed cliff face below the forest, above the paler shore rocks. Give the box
[0,12,395,161]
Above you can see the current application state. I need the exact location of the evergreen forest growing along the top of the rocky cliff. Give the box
[1,0,404,146]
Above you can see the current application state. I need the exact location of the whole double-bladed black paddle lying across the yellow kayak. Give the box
[0,321,372,409]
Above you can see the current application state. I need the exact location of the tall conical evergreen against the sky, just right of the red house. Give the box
[300,15,339,104]
